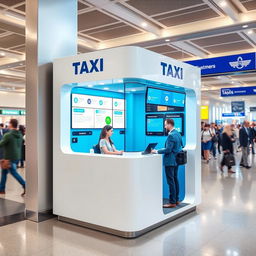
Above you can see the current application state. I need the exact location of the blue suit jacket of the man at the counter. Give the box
[158,129,182,166]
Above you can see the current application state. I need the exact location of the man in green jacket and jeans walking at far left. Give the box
[0,119,25,196]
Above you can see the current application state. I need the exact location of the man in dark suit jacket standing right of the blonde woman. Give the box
[239,121,251,169]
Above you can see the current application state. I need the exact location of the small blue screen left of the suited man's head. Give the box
[146,115,164,135]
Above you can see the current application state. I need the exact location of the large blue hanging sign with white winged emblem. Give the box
[186,52,256,76]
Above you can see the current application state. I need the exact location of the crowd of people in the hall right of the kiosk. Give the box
[201,121,256,173]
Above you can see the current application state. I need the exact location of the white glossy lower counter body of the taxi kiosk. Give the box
[53,152,198,237]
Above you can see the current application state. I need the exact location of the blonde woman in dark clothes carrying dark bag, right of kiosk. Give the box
[220,124,235,173]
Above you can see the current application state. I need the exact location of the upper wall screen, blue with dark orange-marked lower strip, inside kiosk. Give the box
[146,87,186,112]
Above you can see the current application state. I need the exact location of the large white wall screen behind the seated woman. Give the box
[72,94,124,129]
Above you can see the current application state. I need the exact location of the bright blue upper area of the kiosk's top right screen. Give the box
[147,88,185,107]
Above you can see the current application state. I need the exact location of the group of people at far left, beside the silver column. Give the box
[0,119,26,196]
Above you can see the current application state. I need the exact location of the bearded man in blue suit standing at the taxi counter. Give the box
[152,119,182,208]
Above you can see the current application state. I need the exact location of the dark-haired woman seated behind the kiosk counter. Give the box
[99,125,123,155]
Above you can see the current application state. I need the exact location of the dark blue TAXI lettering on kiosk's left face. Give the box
[72,58,104,75]
